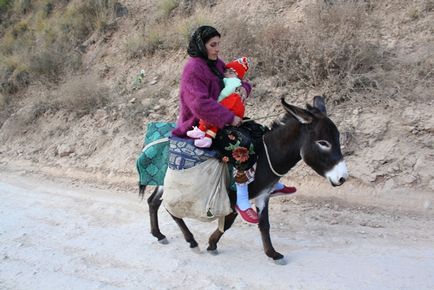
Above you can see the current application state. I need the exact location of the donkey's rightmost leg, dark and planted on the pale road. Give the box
[257,197,286,265]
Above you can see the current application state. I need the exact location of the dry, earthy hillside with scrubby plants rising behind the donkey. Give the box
[0,0,434,212]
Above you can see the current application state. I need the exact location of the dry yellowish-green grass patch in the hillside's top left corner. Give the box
[0,0,115,94]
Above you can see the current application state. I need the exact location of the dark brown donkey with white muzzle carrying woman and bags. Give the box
[140,96,348,264]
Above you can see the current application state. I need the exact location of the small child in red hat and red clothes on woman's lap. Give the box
[187,57,249,148]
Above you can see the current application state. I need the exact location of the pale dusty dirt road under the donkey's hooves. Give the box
[0,172,434,290]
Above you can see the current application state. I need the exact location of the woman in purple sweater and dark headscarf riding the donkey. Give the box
[172,26,296,224]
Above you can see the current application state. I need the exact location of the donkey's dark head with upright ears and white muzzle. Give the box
[282,96,348,186]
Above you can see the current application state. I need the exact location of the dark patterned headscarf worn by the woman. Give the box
[187,26,224,89]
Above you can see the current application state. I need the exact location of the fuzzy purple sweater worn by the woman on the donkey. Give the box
[172,57,251,137]
